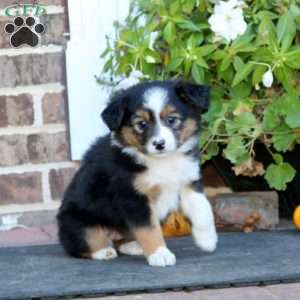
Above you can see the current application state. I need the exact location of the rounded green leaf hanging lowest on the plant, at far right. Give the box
[265,162,296,191]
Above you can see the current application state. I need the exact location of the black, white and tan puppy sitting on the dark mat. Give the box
[58,81,217,266]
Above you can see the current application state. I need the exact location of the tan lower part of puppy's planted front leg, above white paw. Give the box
[133,217,166,256]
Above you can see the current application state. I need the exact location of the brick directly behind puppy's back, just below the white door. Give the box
[49,168,76,200]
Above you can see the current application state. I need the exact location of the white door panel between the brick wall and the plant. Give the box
[66,0,129,160]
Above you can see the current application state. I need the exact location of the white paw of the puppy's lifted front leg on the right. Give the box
[193,228,218,252]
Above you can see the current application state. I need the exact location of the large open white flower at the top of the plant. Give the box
[208,0,247,42]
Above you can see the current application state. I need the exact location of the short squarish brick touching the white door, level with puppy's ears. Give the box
[43,93,65,124]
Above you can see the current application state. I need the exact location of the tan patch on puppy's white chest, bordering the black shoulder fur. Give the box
[133,171,162,201]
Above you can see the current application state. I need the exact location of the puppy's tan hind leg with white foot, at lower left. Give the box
[84,227,118,260]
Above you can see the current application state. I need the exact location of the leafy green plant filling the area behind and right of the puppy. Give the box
[102,0,300,190]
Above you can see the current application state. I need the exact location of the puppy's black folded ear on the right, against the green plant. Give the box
[175,81,210,112]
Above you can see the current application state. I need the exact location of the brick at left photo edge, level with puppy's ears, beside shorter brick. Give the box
[0,94,33,127]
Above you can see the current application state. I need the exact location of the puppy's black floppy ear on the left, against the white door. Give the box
[101,95,126,131]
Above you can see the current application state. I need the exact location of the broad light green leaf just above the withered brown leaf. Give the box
[223,136,250,165]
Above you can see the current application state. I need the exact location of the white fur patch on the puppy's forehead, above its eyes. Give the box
[144,87,168,117]
